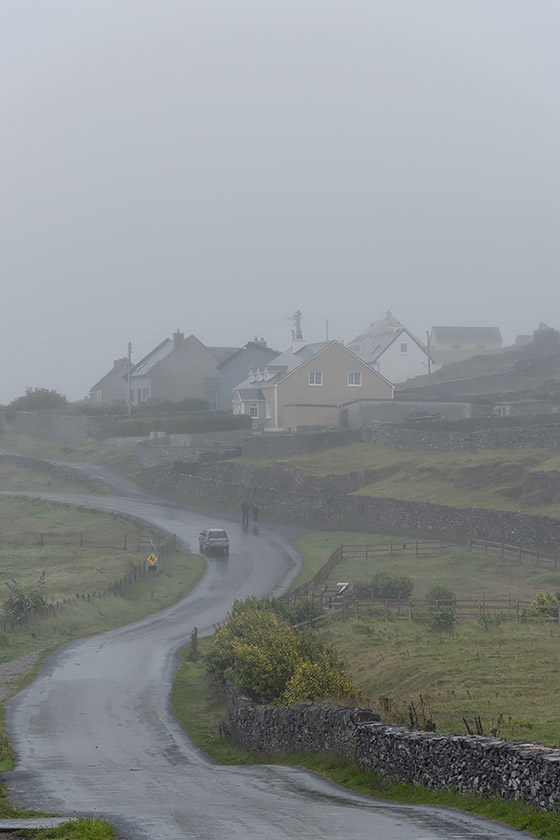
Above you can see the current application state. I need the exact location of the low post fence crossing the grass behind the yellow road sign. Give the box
[0,532,177,633]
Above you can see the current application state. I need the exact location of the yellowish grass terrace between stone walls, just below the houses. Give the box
[235,443,560,516]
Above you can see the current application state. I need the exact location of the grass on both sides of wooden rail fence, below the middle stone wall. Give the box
[294,531,560,601]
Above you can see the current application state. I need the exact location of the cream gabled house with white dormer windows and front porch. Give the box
[233,341,393,432]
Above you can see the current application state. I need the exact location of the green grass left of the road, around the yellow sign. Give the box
[0,496,205,662]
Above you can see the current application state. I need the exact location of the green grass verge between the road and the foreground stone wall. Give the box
[175,638,560,840]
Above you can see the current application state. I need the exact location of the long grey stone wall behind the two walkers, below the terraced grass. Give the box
[140,465,560,550]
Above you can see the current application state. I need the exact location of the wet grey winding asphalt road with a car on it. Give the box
[4,472,526,840]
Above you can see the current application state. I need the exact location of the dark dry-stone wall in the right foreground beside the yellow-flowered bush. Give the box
[228,692,560,809]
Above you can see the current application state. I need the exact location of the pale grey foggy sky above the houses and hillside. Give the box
[0,0,560,403]
